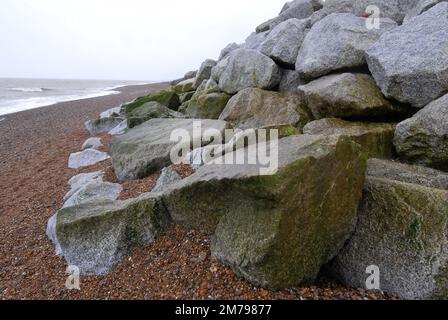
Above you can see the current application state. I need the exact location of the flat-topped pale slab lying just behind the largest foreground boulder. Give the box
[110,119,227,181]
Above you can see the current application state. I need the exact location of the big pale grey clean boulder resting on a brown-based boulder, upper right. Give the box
[296,13,397,79]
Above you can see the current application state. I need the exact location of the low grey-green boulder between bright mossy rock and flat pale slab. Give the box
[128,101,184,128]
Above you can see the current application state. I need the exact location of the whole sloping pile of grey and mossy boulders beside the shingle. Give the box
[49,0,448,299]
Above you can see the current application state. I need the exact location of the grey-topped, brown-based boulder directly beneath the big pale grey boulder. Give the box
[299,73,404,119]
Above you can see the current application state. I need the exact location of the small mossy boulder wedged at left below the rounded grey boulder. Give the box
[186,89,231,119]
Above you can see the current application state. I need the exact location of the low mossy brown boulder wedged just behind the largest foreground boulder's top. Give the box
[303,118,396,159]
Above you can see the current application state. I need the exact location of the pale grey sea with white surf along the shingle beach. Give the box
[0,78,150,119]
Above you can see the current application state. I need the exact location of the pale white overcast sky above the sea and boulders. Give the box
[0,0,286,81]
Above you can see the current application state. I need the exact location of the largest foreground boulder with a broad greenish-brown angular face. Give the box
[164,135,366,289]
